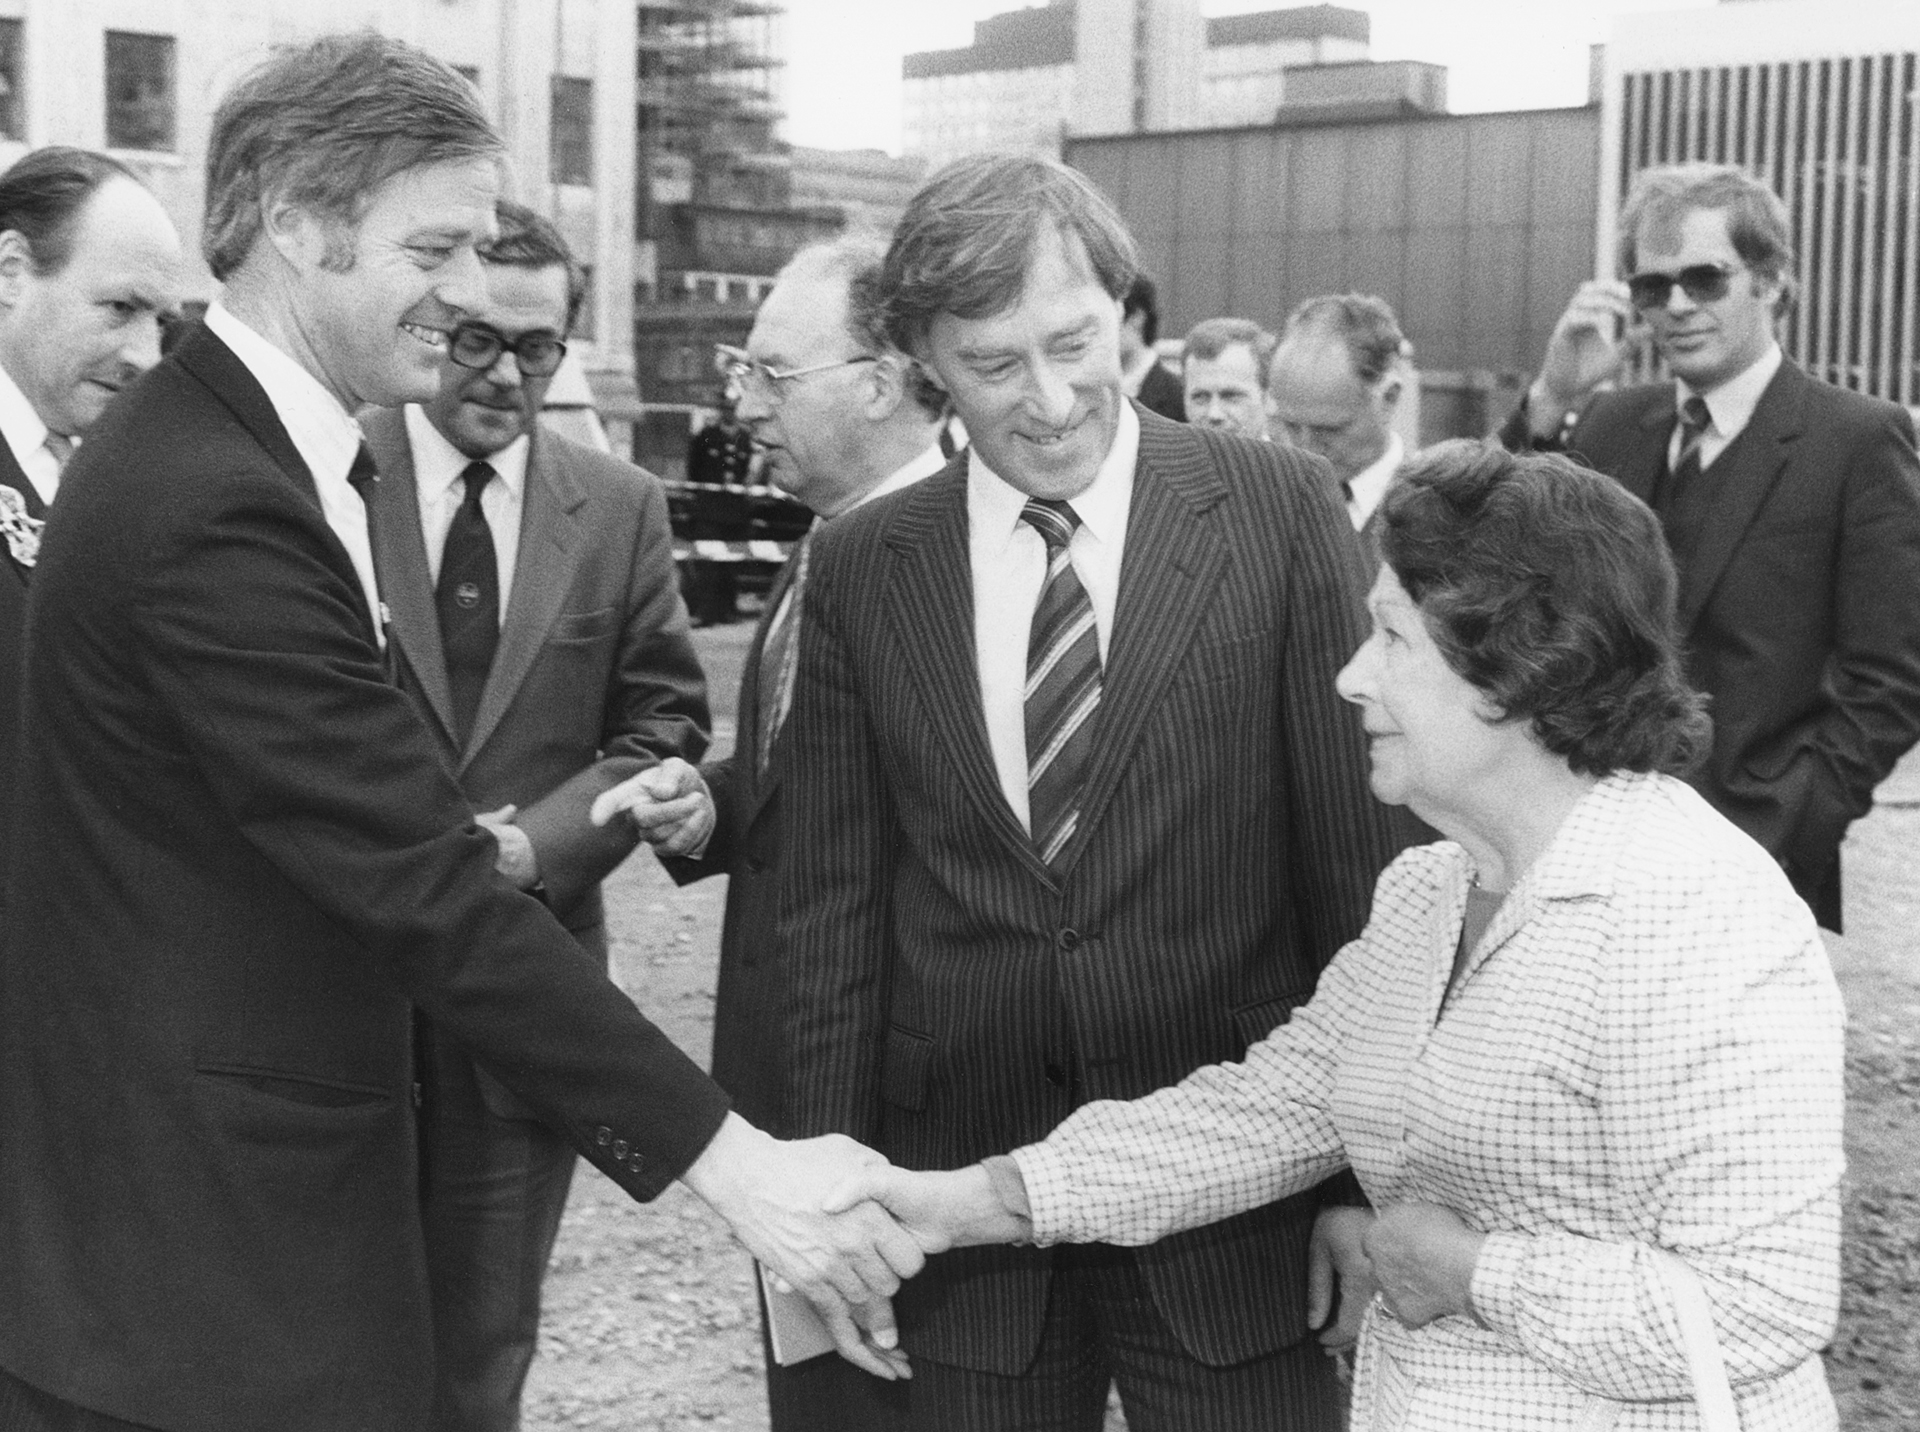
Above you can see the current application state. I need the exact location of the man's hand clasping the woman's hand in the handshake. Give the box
[682,1113,925,1380]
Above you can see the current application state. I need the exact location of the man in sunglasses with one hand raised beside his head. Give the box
[1503,165,1920,929]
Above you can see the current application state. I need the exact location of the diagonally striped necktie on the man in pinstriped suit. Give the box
[1020,497,1100,866]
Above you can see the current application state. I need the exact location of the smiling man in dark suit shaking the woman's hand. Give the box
[0,31,918,1432]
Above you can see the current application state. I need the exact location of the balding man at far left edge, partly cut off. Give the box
[0,146,180,908]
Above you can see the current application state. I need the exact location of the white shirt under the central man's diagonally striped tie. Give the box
[966,403,1140,831]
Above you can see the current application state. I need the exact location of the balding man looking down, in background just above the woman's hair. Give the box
[1269,294,1413,568]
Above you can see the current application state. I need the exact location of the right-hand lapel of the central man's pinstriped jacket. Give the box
[1062,422,1227,870]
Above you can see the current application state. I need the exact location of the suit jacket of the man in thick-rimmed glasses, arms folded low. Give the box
[361,409,708,960]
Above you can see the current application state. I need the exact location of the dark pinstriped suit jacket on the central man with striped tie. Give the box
[781,405,1394,1374]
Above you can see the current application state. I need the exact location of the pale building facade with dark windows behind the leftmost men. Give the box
[0,0,634,415]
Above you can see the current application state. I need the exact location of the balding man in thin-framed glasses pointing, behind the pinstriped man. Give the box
[597,238,948,1432]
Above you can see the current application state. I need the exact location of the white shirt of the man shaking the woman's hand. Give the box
[207,301,386,647]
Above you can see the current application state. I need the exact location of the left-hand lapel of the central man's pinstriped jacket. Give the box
[881,457,1052,881]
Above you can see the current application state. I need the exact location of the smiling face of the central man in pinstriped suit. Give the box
[920,228,1125,497]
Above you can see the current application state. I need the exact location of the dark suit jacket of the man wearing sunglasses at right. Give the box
[1503,363,1920,929]
